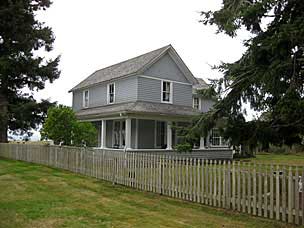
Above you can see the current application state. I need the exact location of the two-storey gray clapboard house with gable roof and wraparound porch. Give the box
[70,45,227,150]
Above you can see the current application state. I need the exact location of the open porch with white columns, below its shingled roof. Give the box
[93,117,227,152]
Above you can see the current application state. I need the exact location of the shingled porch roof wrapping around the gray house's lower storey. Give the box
[76,101,200,120]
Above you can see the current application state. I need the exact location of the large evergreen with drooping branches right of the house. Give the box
[200,0,304,149]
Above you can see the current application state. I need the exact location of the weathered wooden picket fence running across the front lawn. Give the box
[0,144,304,224]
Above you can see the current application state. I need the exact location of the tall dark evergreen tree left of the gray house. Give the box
[0,0,60,142]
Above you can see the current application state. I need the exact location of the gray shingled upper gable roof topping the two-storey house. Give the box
[69,45,198,92]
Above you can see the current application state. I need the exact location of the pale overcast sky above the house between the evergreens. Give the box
[28,0,247,139]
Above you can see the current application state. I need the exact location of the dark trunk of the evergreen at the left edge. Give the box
[0,92,8,143]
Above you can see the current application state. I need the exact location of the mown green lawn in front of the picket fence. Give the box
[0,159,300,228]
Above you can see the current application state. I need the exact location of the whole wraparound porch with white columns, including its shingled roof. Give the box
[77,101,232,159]
